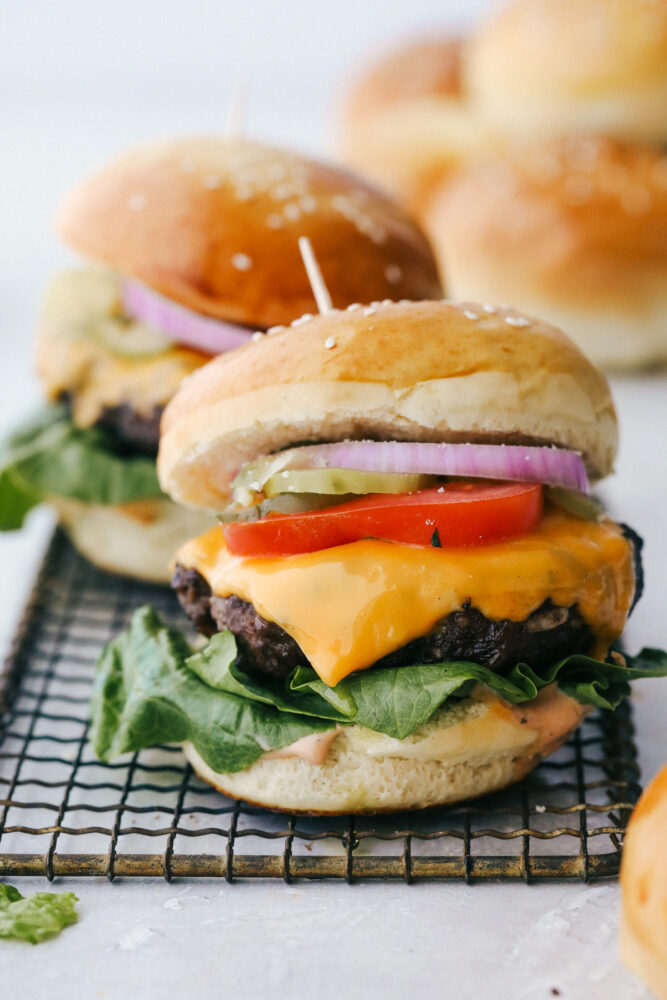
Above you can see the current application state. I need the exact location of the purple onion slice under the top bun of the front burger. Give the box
[283,441,590,493]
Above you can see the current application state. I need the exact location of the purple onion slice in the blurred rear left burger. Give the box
[121,278,252,354]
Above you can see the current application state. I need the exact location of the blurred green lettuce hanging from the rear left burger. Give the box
[0,403,161,531]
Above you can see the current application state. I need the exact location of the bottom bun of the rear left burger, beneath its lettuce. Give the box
[49,497,212,583]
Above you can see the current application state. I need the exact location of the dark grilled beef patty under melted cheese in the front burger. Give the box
[172,565,592,678]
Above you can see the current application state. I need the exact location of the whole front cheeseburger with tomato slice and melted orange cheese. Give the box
[92,301,667,813]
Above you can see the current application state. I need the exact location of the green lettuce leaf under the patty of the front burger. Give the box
[91,607,667,772]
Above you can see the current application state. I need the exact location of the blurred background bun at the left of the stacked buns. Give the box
[338,38,492,214]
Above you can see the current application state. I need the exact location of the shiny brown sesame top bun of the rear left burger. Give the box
[56,138,439,327]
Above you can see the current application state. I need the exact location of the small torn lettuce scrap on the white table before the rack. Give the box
[0,884,79,944]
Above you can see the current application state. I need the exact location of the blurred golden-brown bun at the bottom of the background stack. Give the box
[425,137,667,367]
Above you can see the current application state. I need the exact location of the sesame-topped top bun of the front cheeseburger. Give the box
[158,302,617,508]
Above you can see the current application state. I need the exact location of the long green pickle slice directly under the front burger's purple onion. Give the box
[262,469,437,497]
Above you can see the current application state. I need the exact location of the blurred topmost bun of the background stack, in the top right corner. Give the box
[466,0,667,144]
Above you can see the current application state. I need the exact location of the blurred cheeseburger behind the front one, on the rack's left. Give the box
[0,138,439,581]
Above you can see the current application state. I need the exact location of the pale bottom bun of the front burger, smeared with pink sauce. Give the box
[183,688,587,814]
